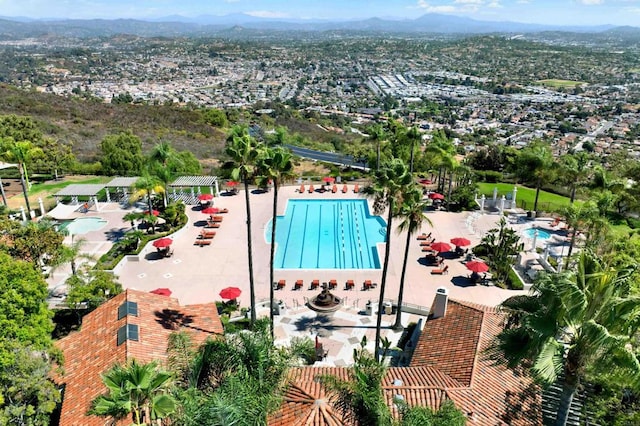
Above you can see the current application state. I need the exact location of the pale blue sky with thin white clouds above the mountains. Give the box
[0,0,640,27]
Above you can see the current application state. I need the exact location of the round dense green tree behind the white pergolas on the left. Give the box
[100,132,144,176]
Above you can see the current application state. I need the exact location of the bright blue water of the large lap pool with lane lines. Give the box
[265,200,386,269]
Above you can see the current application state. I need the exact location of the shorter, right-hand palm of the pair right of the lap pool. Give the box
[393,184,432,330]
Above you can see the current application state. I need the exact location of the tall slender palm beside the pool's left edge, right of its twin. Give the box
[258,147,294,339]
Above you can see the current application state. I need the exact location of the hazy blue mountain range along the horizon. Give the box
[0,13,640,39]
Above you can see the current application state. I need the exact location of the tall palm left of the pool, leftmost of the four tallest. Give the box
[225,130,260,325]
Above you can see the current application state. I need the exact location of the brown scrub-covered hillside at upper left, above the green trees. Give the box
[0,84,226,160]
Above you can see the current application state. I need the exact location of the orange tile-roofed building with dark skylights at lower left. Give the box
[54,289,223,426]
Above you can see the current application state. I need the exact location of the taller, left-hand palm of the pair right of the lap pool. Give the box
[363,158,413,361]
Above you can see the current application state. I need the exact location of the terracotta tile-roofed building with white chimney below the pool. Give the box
[268,293,542,426]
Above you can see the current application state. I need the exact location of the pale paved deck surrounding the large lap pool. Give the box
[48,185,523,365]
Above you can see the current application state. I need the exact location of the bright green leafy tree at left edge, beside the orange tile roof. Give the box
[0,252,60,425]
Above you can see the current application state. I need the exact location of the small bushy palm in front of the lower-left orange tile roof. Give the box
[90,359,176,425]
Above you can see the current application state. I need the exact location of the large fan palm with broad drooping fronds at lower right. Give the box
[490,250,640,425]
